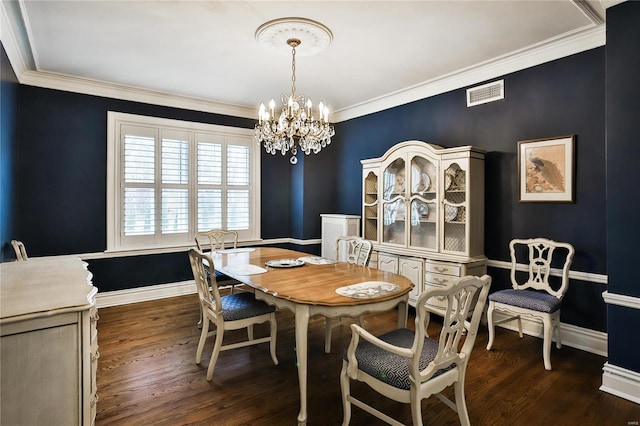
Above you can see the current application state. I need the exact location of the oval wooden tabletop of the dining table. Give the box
[212,247,413,306]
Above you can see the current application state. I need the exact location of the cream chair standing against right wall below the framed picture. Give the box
[487,238,575,370]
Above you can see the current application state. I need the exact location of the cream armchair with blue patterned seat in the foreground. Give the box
[340,275,491,426]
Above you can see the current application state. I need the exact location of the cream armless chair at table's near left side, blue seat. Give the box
[189,249,278,381]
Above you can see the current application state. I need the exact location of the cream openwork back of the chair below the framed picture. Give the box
[509,238,575,299]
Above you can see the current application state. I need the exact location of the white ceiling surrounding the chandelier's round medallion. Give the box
[2,0,609,119]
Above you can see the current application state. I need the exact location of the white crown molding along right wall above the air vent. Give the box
[332,25,606,122]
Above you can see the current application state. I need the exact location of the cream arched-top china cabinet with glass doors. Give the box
[361,141,486,311]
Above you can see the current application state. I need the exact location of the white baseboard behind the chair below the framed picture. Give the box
[494,312,608,357]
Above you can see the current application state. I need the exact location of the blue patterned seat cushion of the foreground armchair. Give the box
[343,328,455,390]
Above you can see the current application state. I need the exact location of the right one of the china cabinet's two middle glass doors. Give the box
[409,155,438,250]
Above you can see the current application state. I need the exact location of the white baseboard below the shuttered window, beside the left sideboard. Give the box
[96,280,196,309]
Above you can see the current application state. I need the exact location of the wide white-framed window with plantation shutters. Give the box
[107,112,260,251]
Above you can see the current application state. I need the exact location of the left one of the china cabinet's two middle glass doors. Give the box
[382,158,407,245]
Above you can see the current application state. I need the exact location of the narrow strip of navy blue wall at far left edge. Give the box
[0,43,19,262]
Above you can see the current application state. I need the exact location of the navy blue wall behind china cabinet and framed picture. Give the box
[335,47,607,331]
